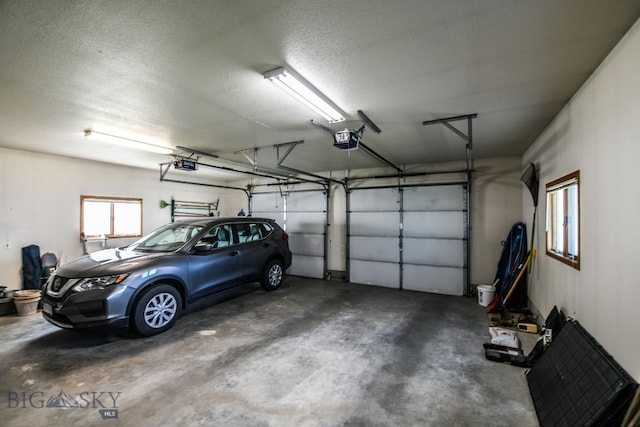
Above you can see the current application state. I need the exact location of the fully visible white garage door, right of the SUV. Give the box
[349,185,466,295]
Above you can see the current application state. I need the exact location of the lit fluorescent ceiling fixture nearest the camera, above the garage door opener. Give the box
[264,67,344,123]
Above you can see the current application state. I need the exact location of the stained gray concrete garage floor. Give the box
[0,276,538,427]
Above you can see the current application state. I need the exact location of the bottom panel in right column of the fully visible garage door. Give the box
[402,264,464,296]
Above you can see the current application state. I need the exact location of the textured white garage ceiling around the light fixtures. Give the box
[0,0,640,178]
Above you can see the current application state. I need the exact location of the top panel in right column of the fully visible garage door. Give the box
[403,185,464,211]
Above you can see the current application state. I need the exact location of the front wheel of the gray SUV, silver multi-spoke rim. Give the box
[133,285,182,336]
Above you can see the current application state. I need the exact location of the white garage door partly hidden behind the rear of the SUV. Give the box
[251,190,327,279]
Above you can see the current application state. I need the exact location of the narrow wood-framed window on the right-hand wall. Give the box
[546,171,580,270]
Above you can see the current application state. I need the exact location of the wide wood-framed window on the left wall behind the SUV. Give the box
[80,196,142,239]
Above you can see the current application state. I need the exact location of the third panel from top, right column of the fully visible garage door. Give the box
[403,238,464,267]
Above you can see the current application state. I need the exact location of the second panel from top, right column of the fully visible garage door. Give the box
[404,211,464,239]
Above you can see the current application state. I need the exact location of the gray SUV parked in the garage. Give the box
[42,217,291,336]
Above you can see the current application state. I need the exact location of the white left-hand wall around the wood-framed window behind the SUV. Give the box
[0,149,238,289]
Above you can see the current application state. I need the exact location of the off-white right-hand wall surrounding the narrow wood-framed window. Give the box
[523,17,640,379]
